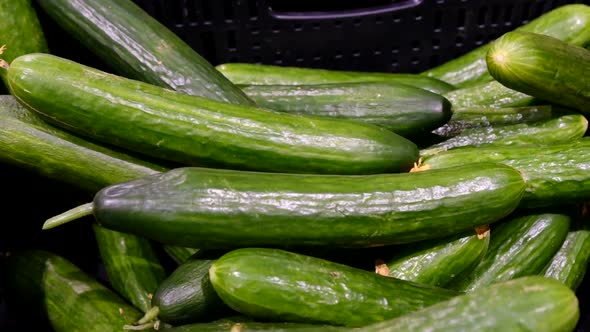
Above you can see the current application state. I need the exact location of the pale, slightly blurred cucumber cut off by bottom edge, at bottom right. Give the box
[355,276,580,332]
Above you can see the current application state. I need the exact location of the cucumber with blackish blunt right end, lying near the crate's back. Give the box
[242,82,451,137]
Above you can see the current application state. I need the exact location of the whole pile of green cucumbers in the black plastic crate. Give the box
[0,0,590,332]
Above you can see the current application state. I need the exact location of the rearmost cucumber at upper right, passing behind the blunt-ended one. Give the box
[422,4,590,88]
